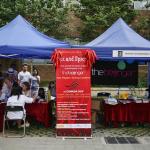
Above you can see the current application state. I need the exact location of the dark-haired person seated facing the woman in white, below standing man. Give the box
[22,82,31,97]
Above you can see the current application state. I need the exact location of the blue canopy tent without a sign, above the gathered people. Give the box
[0,15,70,59]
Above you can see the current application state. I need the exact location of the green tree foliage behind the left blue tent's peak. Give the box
[0,0,68,39]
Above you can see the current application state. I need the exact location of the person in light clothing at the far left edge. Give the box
[0,77,13,101]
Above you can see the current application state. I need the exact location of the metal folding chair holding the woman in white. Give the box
[3,106,26,137]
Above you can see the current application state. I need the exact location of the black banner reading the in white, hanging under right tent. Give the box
[91,61,138,86]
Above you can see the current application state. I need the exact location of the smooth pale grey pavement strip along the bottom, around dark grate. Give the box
[0,137,150,150]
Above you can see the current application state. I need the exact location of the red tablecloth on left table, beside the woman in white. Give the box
[0,102,51,131]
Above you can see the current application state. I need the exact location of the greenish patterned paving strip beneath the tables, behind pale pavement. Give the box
[0,123,150,137]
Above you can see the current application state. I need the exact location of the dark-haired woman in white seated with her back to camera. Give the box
[7,86,36,128]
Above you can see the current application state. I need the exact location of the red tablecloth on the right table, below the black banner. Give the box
[104,102,150,125]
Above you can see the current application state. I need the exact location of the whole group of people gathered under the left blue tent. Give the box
[0,64,56,127]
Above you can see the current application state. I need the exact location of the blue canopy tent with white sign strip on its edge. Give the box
[75,18,150,61]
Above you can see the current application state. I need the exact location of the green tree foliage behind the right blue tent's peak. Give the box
[75,0,136,41]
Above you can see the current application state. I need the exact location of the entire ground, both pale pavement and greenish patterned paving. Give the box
[0,124,150,150]
